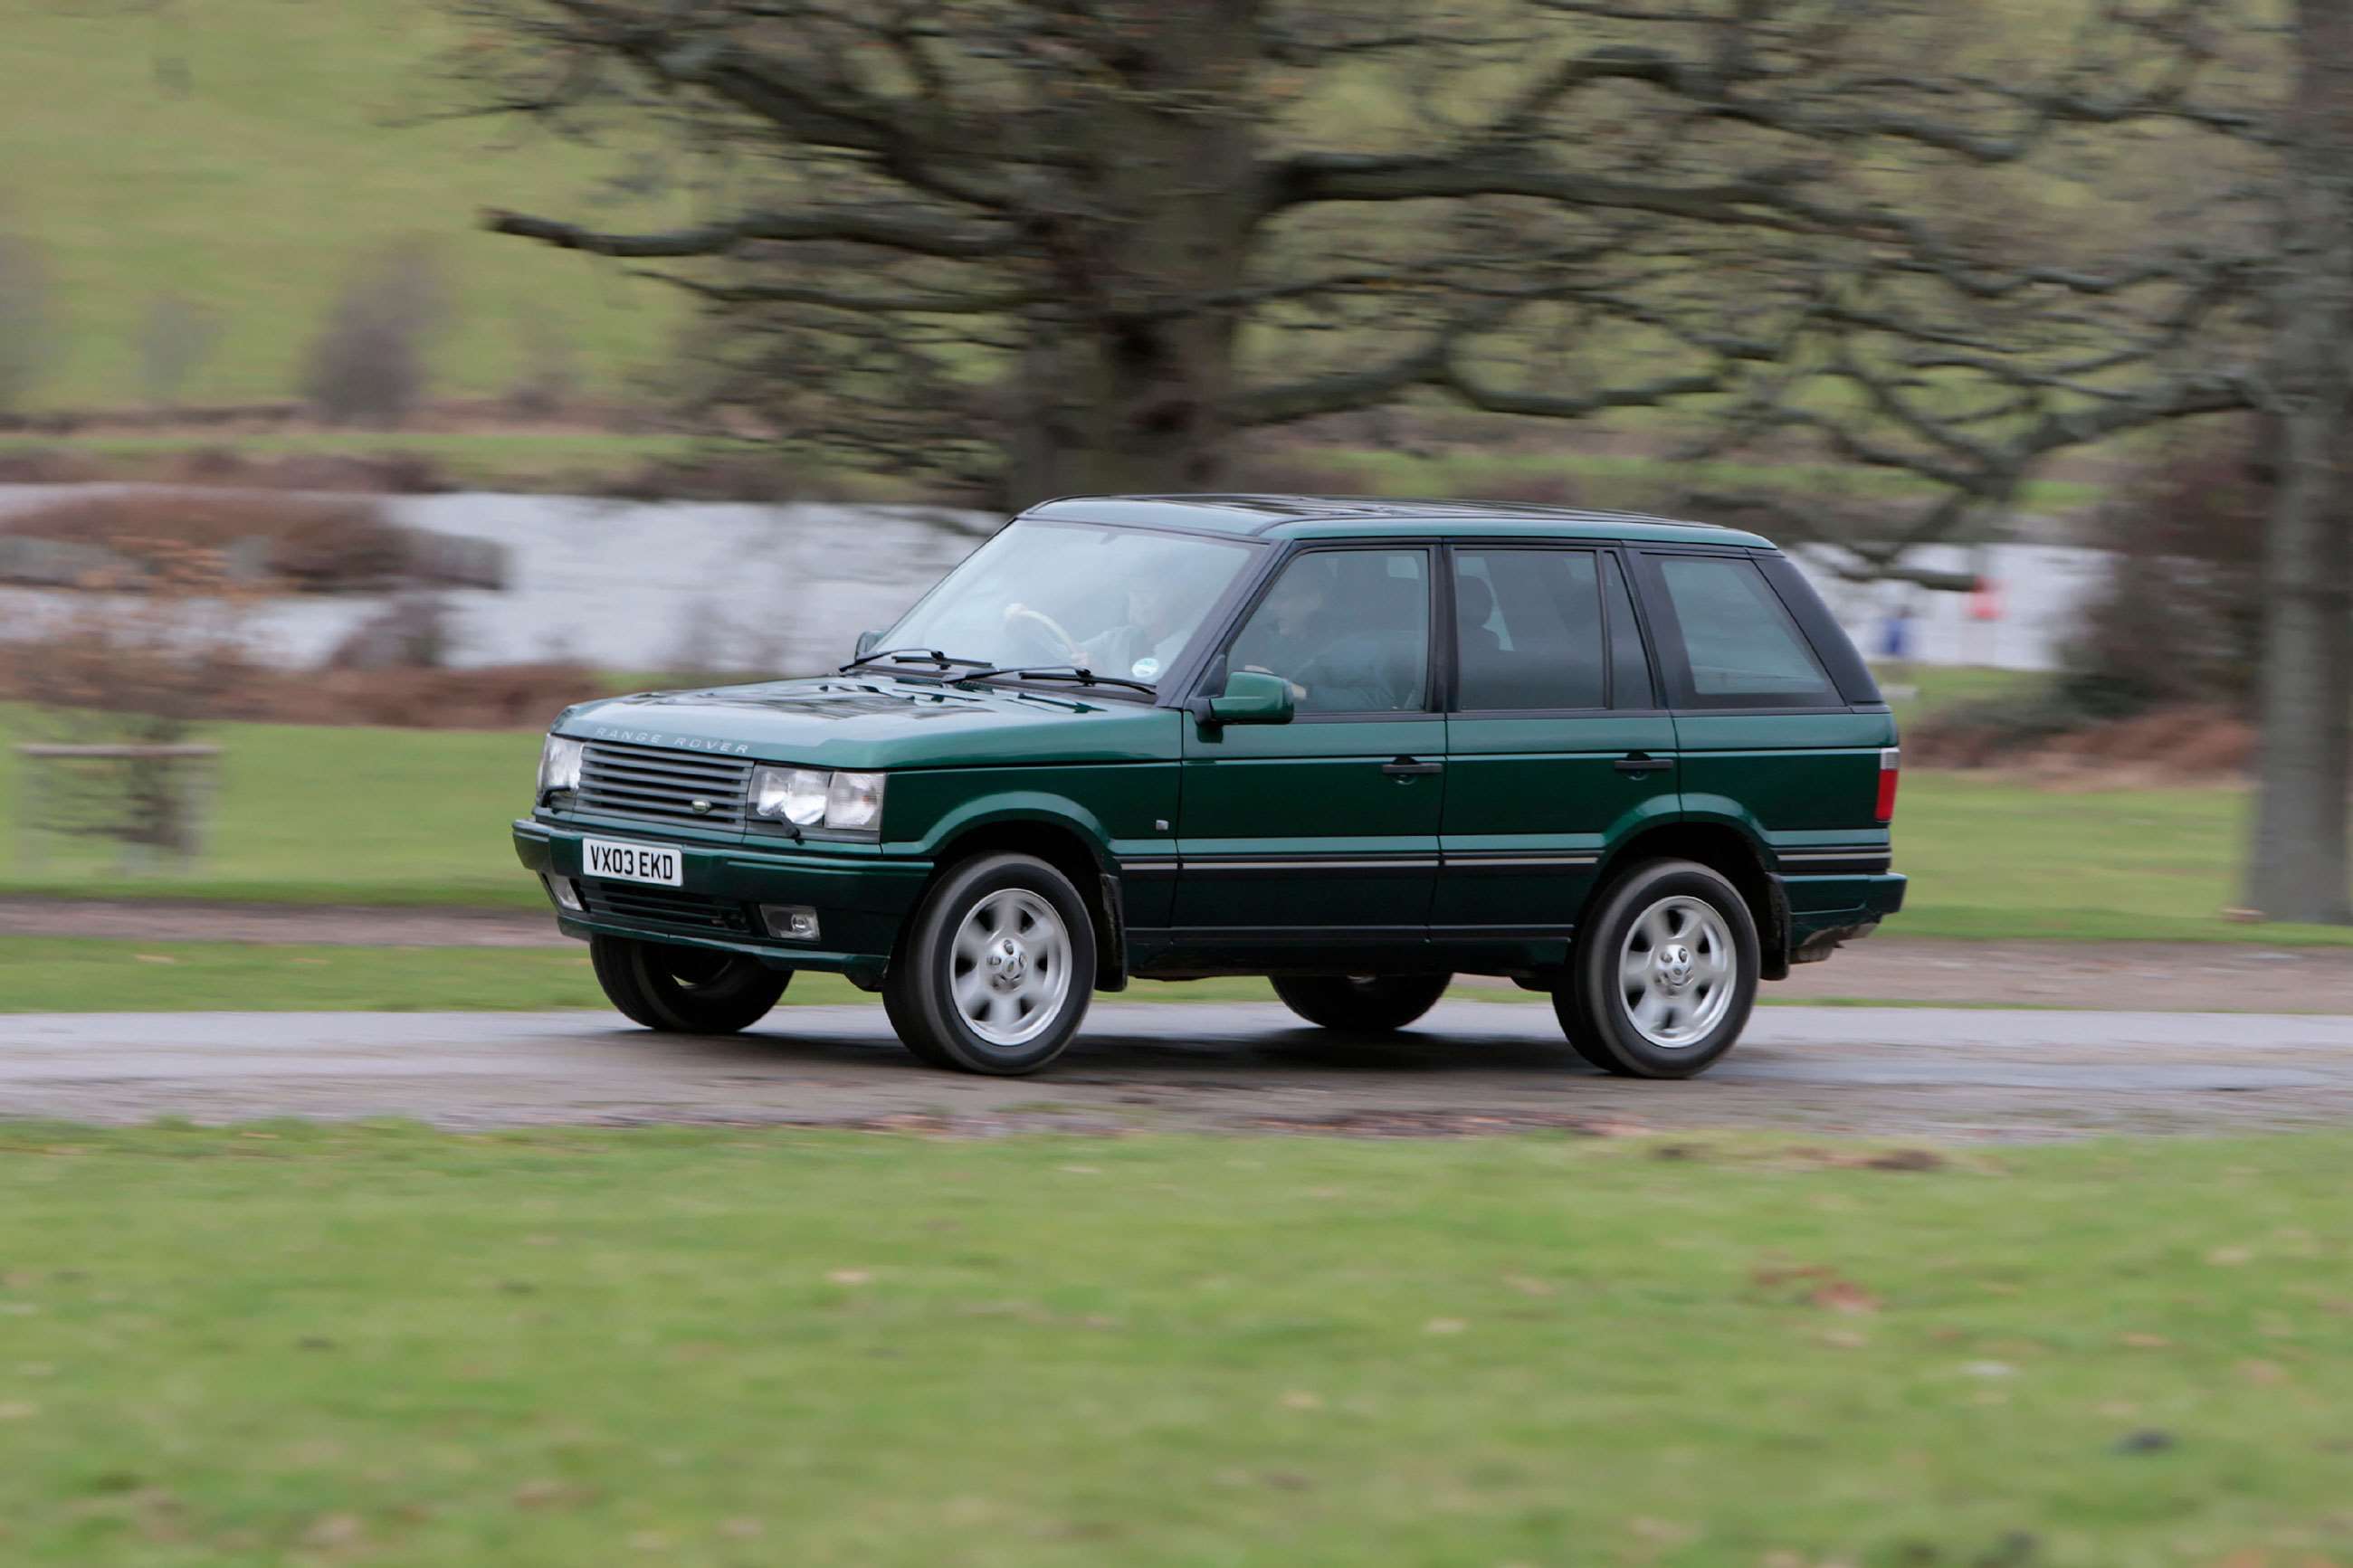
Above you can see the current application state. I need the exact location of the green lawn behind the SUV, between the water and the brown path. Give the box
[0,708,2353,945]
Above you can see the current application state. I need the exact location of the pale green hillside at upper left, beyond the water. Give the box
[0,0,678,406]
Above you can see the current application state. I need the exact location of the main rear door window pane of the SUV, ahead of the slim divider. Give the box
[1454,550,1607,712]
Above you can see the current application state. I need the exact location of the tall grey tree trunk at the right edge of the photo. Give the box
[2247,0,2353,924]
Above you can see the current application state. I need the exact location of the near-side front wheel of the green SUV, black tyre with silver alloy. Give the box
[882,856,1094,1077]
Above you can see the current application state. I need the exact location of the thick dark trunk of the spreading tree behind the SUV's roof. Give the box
[1012,0,1259,503]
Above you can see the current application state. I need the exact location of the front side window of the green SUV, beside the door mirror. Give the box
[1226,547,1431,712]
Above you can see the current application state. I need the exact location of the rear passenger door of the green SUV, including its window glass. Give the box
[1431,543,1678,940]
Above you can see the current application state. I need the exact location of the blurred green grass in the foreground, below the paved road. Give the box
[0,1126,2353,1568]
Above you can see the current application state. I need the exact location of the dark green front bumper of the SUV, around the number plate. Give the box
[515,818,932,980]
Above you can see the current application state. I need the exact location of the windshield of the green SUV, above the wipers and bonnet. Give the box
[875,522,1252,687]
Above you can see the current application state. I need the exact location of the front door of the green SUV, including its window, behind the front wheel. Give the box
[1174,546,1447,945]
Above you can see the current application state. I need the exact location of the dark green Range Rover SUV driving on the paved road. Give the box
[515,496,1903,1077]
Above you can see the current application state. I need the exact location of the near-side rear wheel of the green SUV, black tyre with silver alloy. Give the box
[1553,860,1758,1079]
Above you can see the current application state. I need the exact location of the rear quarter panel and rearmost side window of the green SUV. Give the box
[1635,550,1894,870]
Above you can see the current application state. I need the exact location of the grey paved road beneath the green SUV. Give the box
[0,1002,2353,1138]
